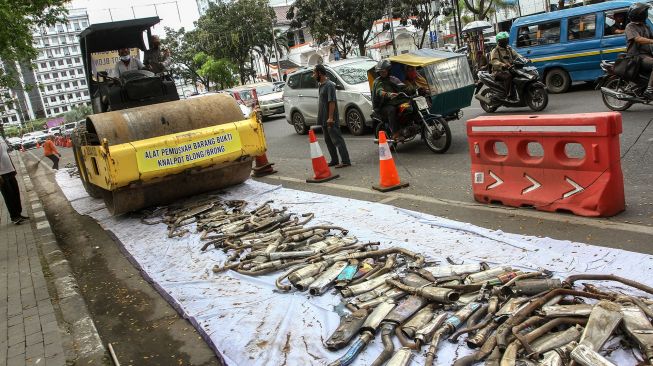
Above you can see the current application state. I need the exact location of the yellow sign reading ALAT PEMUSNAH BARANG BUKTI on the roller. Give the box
[136,130,241,173]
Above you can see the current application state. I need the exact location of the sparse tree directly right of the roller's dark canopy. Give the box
[162,27,209,91]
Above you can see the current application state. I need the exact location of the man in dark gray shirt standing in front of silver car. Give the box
[313,65,351,168]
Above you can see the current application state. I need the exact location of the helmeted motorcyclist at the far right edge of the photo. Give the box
[626,3,653,99]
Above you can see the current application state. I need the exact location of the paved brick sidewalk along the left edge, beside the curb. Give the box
[0,167,65,366]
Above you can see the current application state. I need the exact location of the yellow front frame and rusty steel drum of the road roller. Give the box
[76,94,266,214]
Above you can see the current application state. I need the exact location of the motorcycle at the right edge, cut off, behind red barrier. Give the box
[596,61,651,111]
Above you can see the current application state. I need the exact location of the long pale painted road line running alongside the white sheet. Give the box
[262,175,653,235]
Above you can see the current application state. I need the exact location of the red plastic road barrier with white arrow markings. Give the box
[467,112,626,216]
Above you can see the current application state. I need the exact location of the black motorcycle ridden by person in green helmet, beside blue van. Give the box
[474,58,549,113]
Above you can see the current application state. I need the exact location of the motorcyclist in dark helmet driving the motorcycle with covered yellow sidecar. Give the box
[372,60,406,140]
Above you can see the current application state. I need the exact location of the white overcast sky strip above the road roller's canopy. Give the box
[72,0,199,34]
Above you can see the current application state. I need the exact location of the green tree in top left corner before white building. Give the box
[0,0,68,88]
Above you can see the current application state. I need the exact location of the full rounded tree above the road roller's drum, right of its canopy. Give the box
[197,0,275,84]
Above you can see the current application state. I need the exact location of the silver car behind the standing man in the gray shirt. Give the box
[283,57,376,135]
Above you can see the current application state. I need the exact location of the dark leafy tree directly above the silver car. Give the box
[286,0,385,58]
